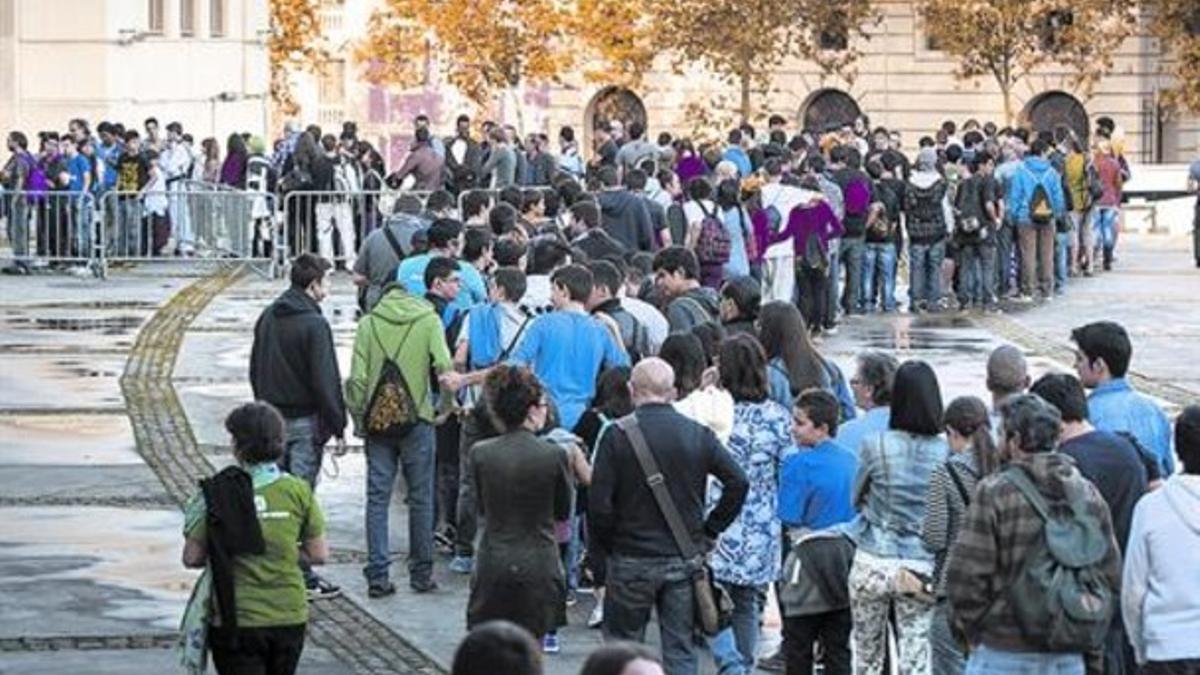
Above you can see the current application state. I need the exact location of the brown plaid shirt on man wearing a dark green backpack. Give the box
[946,453,1121,661]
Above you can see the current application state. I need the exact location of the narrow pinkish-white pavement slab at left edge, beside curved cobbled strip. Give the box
[0,414,142,466]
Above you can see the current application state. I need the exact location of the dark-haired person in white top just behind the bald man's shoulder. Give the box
[659,333,733,443]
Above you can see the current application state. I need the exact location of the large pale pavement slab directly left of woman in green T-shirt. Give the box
[0,507,196,638]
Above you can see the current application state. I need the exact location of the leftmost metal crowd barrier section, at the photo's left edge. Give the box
[0,190,100,268]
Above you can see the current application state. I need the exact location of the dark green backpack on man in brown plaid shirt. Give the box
[1002,467,1117,652]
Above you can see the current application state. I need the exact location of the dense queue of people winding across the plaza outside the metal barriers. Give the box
[164,107,1200,675]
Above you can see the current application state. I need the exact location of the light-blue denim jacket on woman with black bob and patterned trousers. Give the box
[854,430,949,561]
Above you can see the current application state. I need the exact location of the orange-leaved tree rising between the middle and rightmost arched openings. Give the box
[918,0,1138,124]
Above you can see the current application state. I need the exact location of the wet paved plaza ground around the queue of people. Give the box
[0,229,1200,675]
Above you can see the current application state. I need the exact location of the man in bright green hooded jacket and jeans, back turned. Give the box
[346,283,461,598]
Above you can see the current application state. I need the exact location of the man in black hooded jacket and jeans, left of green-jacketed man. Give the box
[250,253,346,597]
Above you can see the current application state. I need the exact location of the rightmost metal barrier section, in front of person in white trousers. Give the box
[282,190,431,269]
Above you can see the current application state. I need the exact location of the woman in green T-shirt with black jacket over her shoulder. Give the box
[184,402,329,675]
